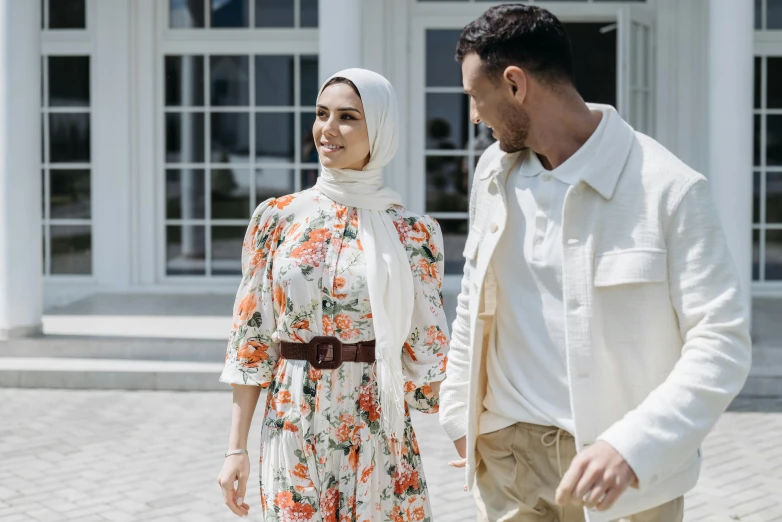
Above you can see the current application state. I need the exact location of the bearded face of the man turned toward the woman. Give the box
[462,53,530,152]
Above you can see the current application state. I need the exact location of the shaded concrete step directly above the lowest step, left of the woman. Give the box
[0,335,227,363]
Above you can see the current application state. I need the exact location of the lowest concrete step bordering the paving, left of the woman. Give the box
[0,357,231,391]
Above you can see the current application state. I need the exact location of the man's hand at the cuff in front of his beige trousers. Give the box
[555,441,638,511]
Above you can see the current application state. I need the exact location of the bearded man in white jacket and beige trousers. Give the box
[440,4,750,522]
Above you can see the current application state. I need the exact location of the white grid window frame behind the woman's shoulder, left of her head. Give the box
[155,0,319,282]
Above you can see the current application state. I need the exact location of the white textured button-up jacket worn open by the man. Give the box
[440,106,751,522]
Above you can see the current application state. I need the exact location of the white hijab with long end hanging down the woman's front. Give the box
[315,69,414,442]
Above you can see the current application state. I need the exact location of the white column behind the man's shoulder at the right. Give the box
[708,0,754,308]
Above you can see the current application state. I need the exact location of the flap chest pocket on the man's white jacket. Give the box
[594,248,668,287]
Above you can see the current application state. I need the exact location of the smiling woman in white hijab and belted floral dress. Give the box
[219,69,448,522]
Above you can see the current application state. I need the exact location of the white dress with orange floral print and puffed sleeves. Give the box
[220,189,448,522]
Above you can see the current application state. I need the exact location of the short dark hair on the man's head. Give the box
[456,4,574,84]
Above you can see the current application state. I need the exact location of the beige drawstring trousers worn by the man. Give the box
[474,423,684,522]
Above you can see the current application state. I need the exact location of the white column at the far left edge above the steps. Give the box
[0,0,43,339]
